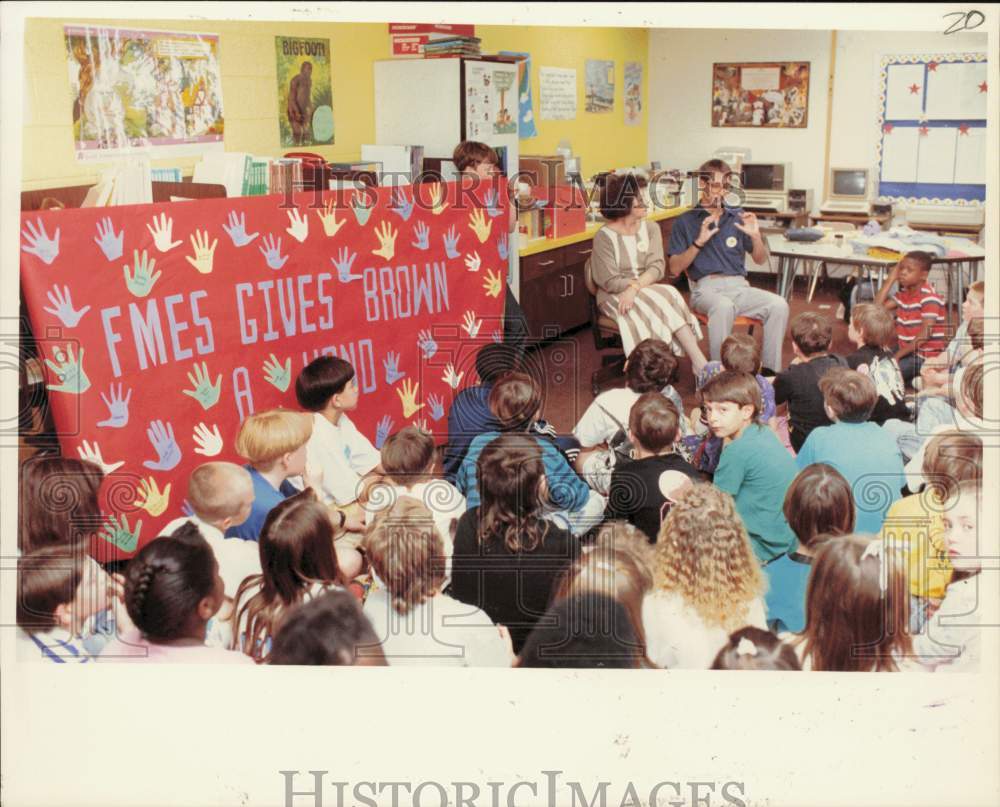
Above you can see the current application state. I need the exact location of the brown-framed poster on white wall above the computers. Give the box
[712,62,809,129]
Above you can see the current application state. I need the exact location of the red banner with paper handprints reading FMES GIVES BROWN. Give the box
[21,183,508,558]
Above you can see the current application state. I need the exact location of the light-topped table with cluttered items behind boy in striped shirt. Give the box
[767,235,986,331]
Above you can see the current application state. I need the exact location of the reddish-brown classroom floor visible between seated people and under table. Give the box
[535,274,854,433]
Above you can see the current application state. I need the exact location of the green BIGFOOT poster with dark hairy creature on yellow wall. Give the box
[274,36,334,148]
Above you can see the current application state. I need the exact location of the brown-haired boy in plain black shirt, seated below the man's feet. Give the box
[774,311,845,451]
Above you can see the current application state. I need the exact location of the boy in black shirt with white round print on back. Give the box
[604,392,704,543]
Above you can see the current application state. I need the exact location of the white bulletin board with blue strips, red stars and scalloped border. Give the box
[876,53,989,205]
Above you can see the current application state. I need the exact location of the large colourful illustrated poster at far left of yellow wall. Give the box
[63,25,224,159]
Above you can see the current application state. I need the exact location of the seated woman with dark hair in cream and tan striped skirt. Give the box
[590,174,706,375]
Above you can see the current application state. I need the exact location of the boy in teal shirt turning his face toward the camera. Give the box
[701,370,797,560]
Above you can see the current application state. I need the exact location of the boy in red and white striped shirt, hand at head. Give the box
[875,250,945,384]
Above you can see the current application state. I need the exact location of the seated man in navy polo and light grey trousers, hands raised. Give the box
[667,160,788,372]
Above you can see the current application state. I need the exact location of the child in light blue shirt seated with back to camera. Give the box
[796,367,905,534]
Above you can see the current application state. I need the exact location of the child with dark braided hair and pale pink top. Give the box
[98,523,250,664]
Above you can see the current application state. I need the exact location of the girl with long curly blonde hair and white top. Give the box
[642,484,767,670]
